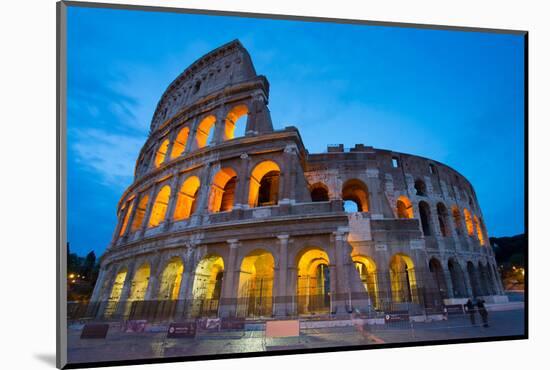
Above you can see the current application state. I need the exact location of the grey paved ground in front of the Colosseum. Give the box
[68,310,524,363]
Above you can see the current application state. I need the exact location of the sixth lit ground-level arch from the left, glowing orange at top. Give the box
[296,248,331,314]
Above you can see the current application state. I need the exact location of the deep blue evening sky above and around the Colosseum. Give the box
[68,7,524,255]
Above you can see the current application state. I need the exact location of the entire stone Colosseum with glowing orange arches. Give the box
[91,40,506,320]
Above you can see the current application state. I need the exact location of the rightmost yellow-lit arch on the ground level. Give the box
[390,253,418,303]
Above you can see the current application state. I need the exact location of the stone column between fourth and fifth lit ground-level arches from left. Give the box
[219,239,239,317]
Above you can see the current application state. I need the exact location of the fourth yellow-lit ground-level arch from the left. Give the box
[192,255,224,316]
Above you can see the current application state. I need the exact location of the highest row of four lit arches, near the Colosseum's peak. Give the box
[154,104,248,168]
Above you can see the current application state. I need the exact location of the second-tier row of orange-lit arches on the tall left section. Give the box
[119,160,281,236]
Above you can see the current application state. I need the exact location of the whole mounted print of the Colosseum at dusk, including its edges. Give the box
[57,1,528,368]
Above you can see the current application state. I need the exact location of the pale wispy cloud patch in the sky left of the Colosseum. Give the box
[71,129,145,188]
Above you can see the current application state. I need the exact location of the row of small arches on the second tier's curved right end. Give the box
[396,195,485,245]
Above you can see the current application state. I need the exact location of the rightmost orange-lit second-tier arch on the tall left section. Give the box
[248,161,281,208]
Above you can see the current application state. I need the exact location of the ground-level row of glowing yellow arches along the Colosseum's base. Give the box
[102,247,432,317]
